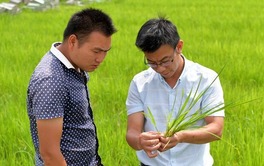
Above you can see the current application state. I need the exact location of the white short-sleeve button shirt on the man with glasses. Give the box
[126,56,224,166]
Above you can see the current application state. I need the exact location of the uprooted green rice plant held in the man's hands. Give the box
[145,67,253,141]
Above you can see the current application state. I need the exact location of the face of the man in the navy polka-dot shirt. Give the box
[70,32,111,72]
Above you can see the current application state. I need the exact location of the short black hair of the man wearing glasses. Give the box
[136,17,180,52]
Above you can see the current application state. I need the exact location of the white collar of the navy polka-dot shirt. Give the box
[50,42,75,69]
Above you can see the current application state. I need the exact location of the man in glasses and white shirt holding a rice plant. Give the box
[126,18,224,166]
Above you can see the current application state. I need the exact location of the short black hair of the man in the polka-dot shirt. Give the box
[63,8,117,43]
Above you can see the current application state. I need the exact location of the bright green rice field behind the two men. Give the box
[0,0,264,166]
